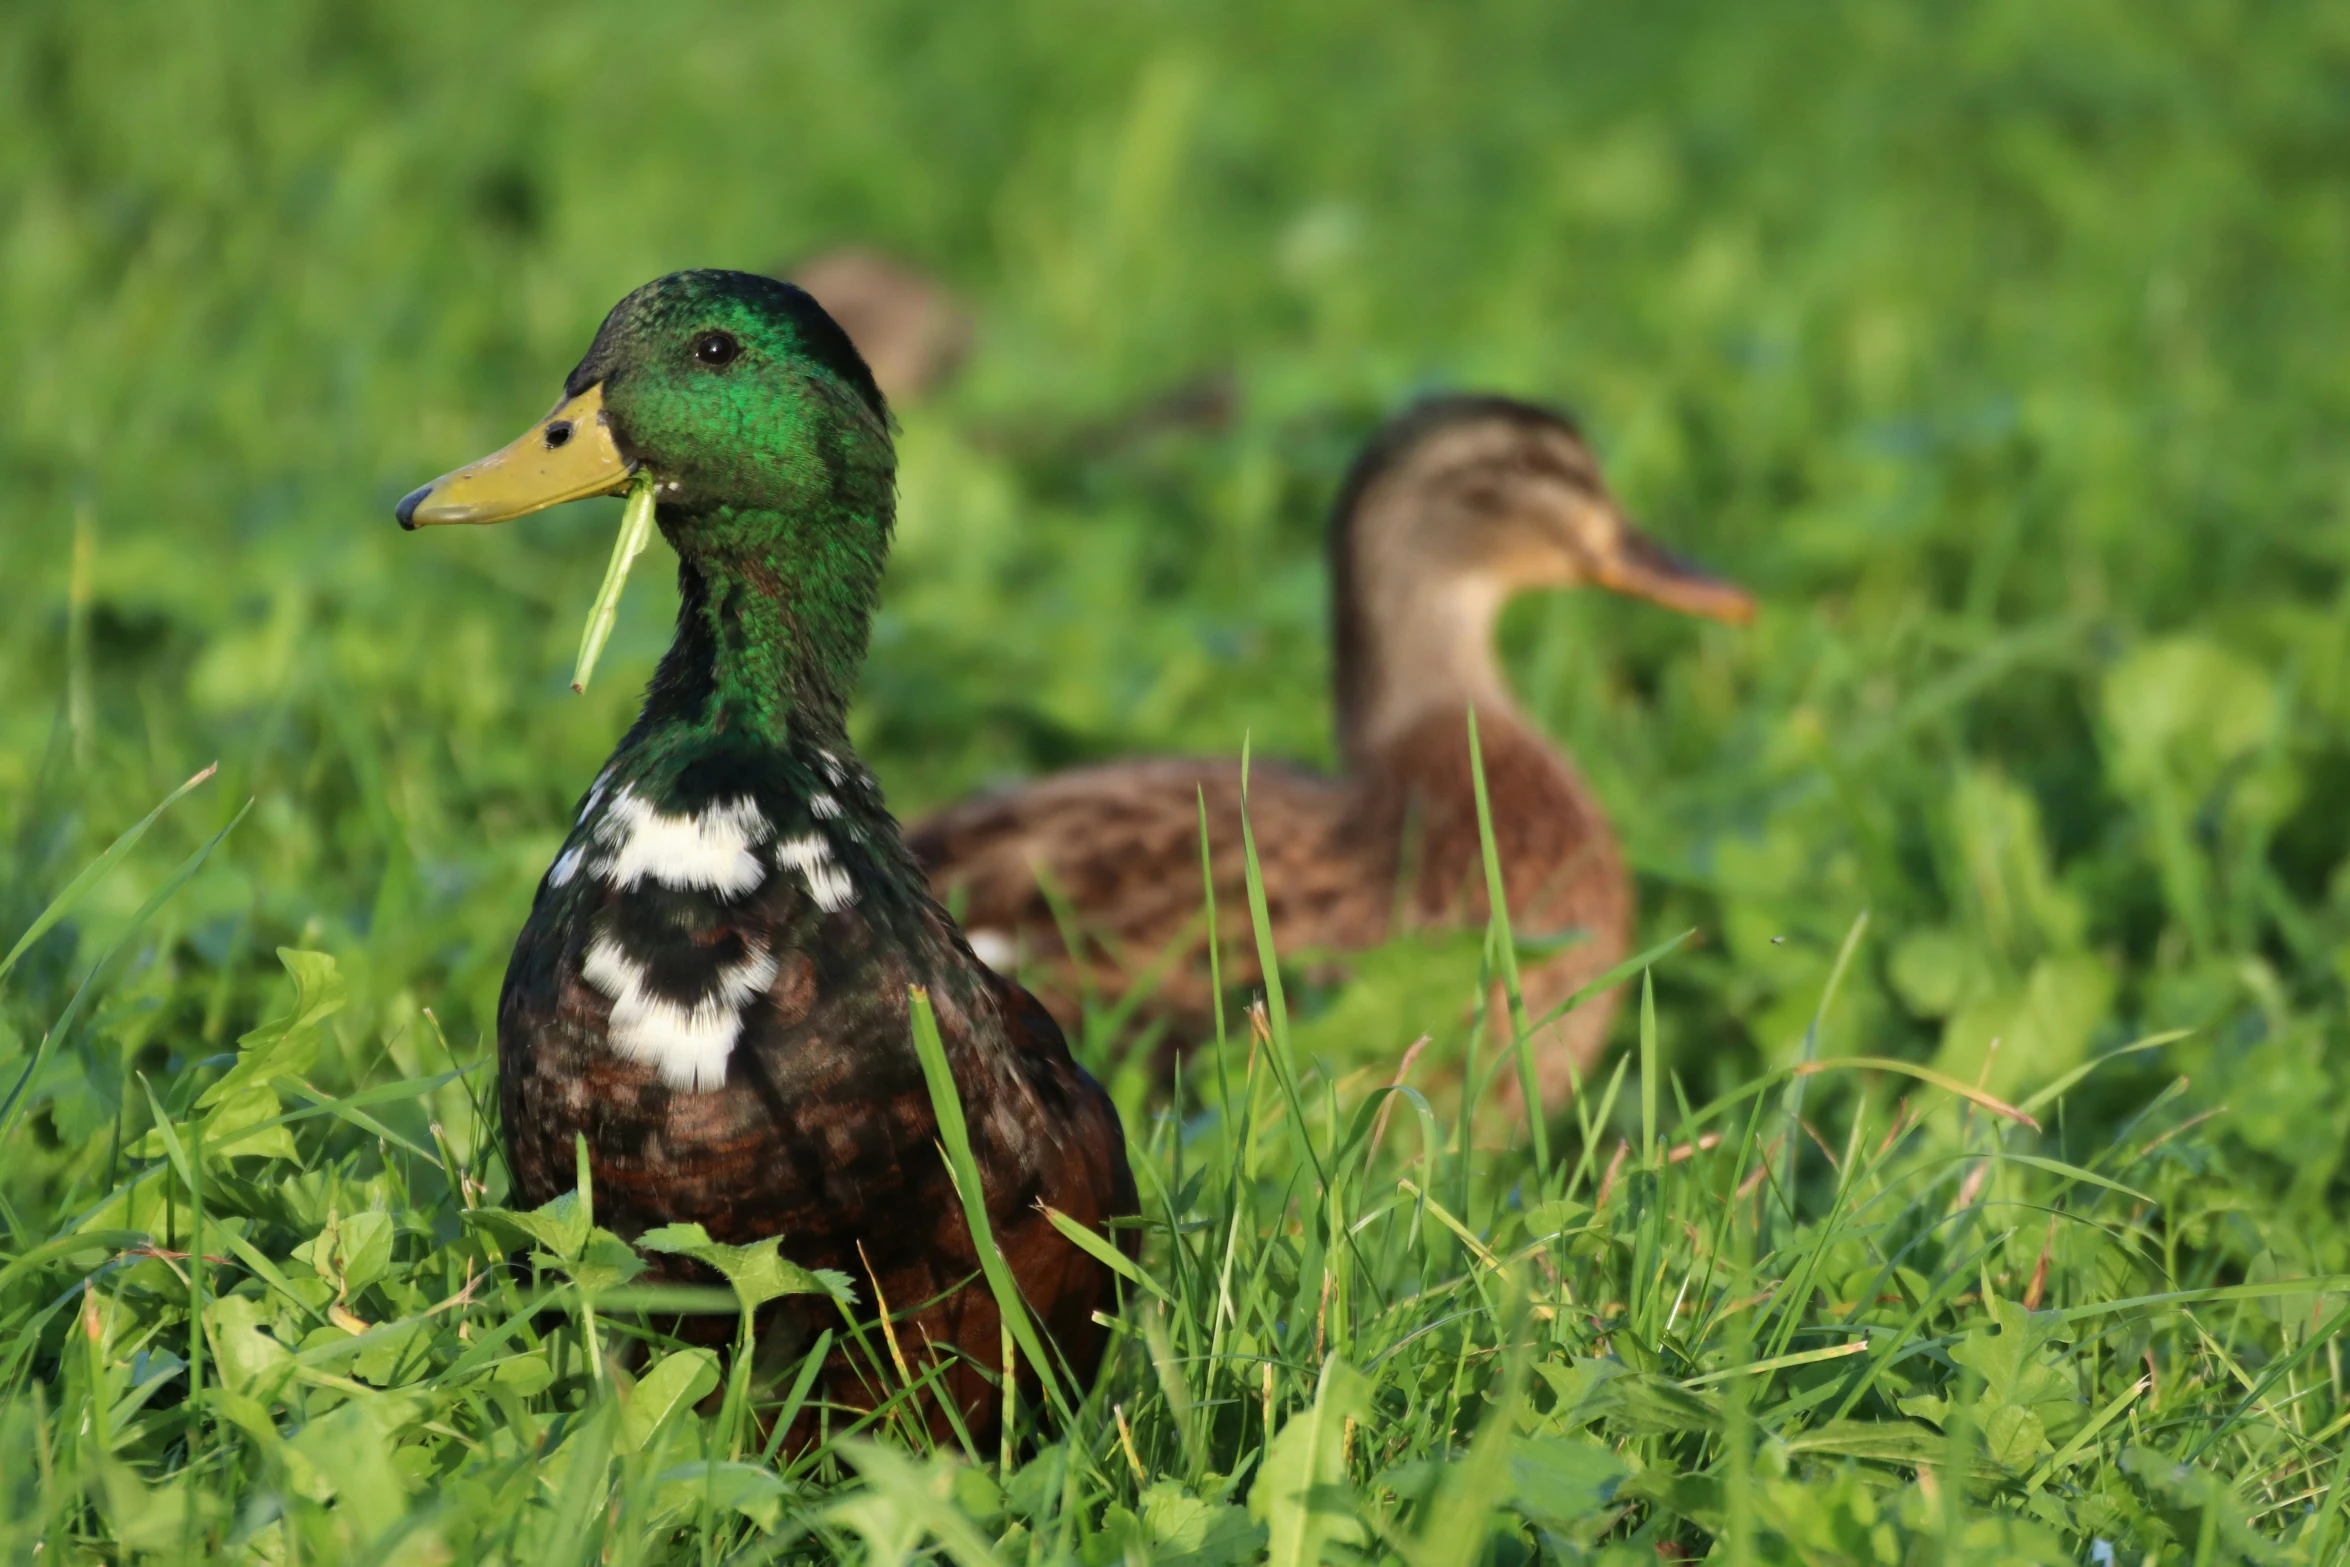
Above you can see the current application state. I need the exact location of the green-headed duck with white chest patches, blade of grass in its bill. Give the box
[397,270,1135,1447]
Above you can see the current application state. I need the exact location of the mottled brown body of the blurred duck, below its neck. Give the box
[907,709,1633,1099]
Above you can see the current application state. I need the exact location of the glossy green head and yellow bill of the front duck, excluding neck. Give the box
[397,270,891,535]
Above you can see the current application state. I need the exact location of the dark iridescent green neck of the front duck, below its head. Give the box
[632,495,886,749]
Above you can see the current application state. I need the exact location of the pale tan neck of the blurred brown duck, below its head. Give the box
[1330,505,1516,768]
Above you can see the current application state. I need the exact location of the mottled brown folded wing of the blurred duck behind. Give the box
[907,756,1396,1034]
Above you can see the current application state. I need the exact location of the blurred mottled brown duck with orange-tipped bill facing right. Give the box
[907,392,1753,1109]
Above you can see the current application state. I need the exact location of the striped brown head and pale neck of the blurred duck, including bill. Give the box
[1330,397,1753,759]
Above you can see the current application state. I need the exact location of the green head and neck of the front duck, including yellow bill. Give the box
[397,270,895,738]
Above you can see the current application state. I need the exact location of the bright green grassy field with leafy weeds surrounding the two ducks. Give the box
[0,0,2350,1567]
